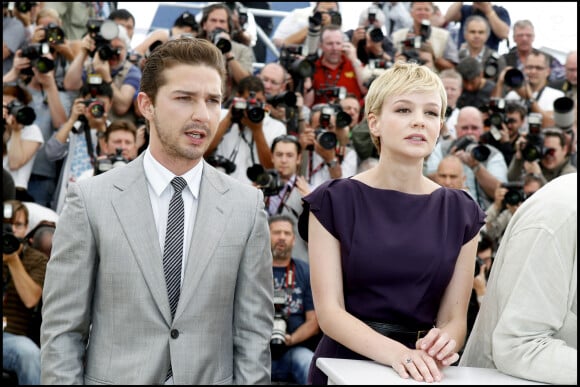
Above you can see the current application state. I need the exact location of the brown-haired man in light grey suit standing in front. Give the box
[41,38,274,384]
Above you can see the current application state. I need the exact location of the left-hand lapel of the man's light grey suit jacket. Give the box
[113,155,171,324]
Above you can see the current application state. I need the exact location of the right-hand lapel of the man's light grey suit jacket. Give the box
[175,162,229,319]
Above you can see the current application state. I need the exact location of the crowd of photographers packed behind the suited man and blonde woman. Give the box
[3,2,577,384]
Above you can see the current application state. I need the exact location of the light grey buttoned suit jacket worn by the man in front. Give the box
[41,155,274,384]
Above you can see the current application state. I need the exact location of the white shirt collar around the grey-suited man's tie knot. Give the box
[143,148,203,199]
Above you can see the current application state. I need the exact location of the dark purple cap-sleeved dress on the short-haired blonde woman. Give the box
[300,178,485,384]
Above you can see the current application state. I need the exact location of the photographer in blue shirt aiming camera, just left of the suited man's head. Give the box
[64,20,141,123]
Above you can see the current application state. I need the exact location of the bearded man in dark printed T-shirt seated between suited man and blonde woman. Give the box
[268,215,320,384]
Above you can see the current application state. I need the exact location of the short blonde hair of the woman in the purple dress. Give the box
[365,61,447,154]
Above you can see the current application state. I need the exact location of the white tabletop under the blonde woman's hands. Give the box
[316,357,544,386]
